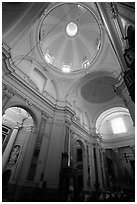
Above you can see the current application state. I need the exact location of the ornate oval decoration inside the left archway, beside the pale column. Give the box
[8,145,21,167]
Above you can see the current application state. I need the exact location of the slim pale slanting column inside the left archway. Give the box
[2,123,21,172]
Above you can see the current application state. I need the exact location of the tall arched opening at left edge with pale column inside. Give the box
[2,106,35,178]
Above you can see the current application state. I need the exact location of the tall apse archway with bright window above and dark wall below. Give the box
[95,107,135,190]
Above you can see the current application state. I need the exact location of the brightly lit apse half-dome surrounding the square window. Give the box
[95,107,134,141]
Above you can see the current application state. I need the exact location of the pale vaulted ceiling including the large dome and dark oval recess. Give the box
[2,2,135,142]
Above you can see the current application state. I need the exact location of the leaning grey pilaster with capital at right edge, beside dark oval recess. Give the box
[114,78,135,125]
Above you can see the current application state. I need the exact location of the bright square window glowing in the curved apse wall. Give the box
[111,118,127,134]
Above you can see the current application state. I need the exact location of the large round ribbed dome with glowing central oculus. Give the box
[39,3,101,73]
